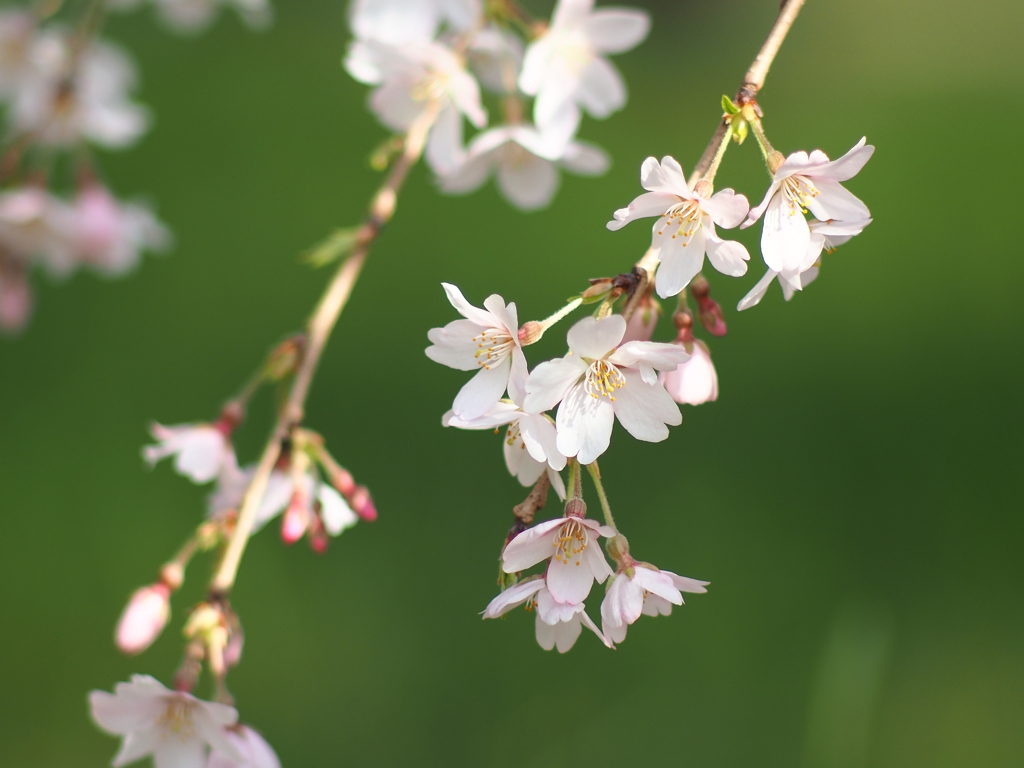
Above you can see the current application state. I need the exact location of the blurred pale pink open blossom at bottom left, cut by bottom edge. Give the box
[89,675,239,768]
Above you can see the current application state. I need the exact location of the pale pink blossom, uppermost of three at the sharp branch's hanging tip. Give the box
[502,515,615,605]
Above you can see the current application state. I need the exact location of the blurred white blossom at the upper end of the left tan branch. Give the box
[345,40,487,175]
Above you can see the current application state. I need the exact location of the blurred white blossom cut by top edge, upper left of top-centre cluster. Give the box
[349,0,483,45]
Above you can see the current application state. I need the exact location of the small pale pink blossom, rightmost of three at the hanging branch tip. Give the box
[601,563,710,643]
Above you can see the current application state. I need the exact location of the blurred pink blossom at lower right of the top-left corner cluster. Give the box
[72,183,171,274]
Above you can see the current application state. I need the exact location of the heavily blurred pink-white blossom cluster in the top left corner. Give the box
[0,0,269,332]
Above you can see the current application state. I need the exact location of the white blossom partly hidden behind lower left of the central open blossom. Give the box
[441,386,566,499]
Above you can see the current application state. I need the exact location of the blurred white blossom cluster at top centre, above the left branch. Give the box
[345,0,649,210]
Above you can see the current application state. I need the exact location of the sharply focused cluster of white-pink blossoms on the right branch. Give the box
[426,79,873,652]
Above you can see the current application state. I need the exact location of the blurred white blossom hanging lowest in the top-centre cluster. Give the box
[440,125,610,211]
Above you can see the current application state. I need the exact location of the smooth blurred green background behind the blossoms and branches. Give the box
[0,0,1024,768]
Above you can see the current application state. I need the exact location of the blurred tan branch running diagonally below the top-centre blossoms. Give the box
[210,102,439,595]
